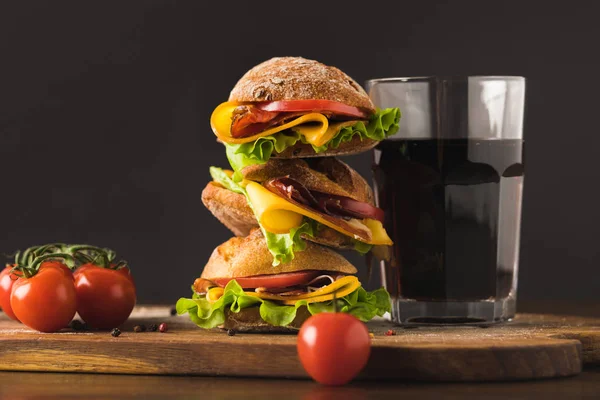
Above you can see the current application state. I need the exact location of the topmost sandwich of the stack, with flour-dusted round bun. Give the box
[210,57,400,179]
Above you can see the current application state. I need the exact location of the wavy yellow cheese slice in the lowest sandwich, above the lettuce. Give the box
[206,276,361,306]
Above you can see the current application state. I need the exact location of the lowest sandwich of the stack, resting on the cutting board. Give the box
[176,228,390,332]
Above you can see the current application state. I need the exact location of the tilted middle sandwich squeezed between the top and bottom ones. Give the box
[202,157,392,265]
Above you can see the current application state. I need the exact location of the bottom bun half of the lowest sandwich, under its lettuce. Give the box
[219,306,311,333]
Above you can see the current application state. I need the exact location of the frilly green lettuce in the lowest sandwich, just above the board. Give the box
[176,280,391,329]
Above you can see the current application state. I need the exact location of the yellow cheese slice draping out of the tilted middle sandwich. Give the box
[246,182,393,245]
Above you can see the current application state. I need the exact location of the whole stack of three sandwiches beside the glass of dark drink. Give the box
[177,57,400,332]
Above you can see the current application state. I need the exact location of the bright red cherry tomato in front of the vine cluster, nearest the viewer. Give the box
[10,261,77,332]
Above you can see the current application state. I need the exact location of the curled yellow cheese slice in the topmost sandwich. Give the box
[210,101,329,144]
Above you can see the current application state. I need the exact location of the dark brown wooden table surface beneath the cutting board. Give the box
[0,304,600,400]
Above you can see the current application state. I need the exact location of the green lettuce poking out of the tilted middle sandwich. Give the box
[210,167,318,266]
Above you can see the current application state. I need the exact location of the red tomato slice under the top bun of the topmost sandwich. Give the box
[254,100,369,119]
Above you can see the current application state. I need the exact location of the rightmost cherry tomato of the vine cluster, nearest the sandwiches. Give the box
[74,264,136,329]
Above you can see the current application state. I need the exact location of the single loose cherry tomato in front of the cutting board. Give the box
[297,313,371,385]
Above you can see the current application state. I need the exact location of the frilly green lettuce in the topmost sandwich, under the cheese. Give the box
[225,108,400,176]
